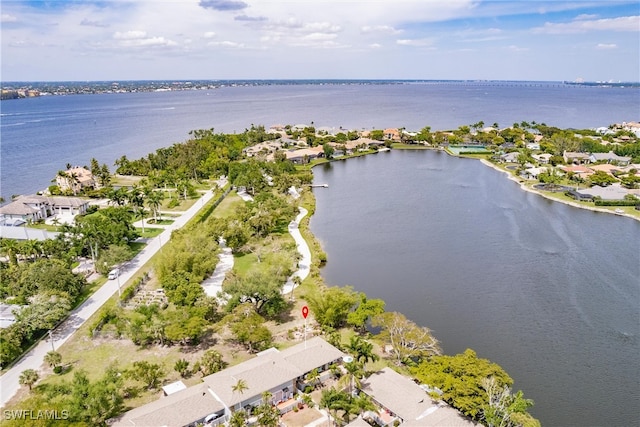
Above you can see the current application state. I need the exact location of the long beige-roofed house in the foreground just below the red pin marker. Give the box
[110,337,344,427]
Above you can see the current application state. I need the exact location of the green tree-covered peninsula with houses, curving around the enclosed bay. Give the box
[0,118,640,426]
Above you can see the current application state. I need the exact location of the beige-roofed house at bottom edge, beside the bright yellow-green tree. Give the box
[361,368,476,427]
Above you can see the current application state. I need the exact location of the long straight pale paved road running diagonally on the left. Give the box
[0,191,213,407]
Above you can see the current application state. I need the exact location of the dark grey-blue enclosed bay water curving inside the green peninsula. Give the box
[311,151,640,426]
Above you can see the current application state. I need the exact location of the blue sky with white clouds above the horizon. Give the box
[0,0,640,82]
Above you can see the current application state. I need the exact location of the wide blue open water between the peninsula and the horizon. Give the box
[0,83,640,200]
